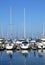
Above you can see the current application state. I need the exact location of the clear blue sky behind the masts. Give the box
[0,0,45,37]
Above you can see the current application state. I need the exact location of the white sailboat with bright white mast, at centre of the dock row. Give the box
[20,8,30,50]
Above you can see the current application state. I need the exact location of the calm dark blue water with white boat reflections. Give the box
[0,50,45,65]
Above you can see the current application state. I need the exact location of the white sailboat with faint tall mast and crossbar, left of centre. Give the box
[6,7,14,50]
